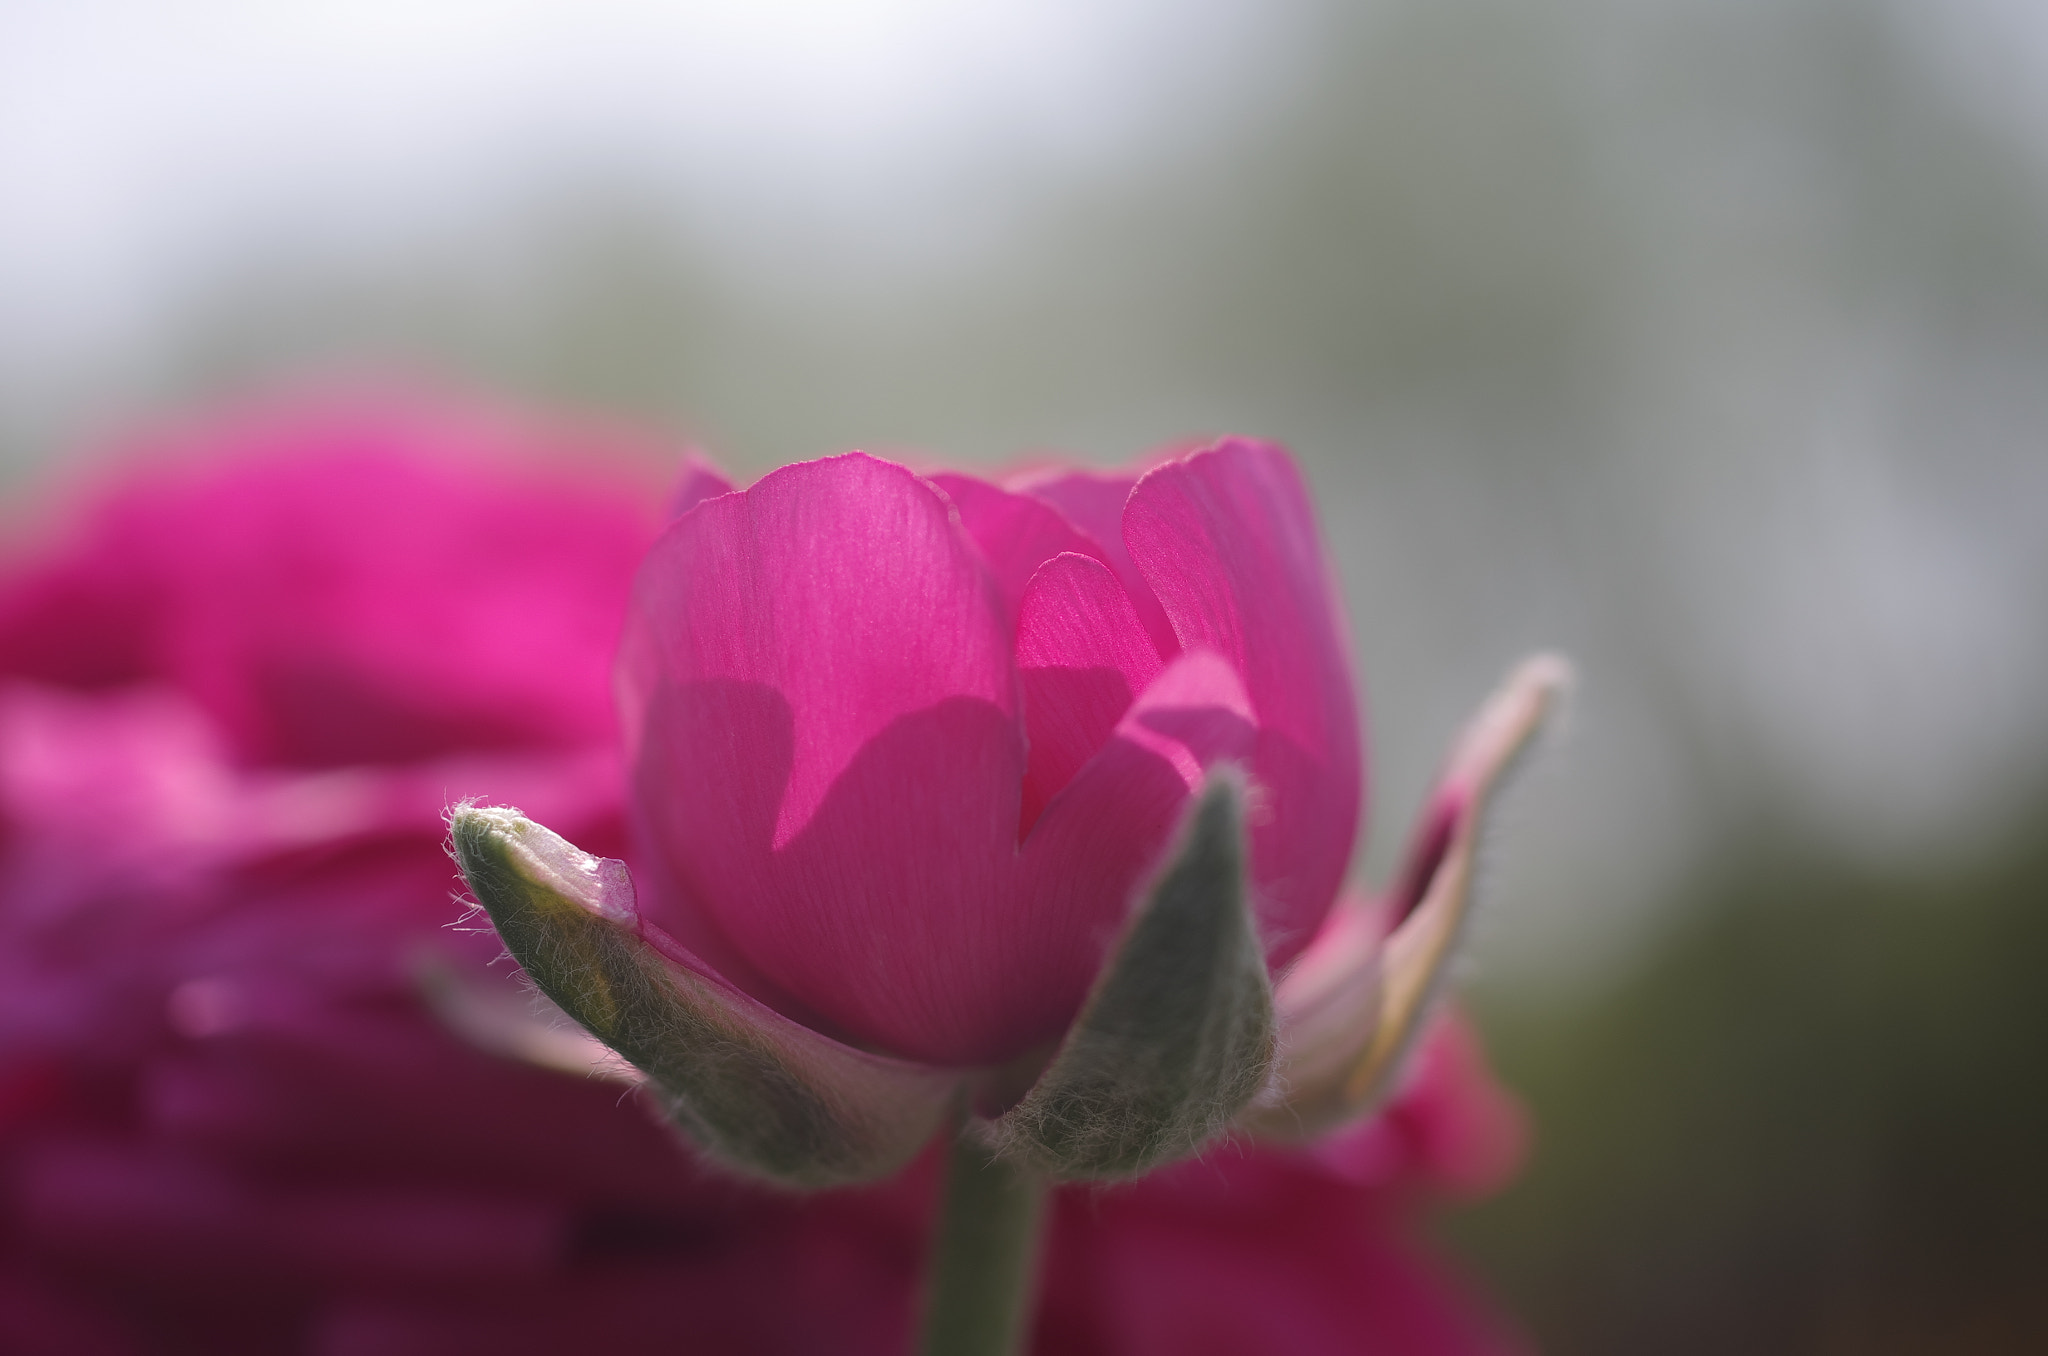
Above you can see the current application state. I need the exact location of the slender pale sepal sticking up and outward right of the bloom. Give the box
[1243,655,1571,1139]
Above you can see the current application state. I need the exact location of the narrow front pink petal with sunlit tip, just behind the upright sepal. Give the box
[1018,651,1255,1039]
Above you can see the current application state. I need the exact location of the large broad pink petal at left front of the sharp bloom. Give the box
[618,455,1032,1061]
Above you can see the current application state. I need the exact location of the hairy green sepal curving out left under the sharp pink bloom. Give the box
[449,807,956,1188]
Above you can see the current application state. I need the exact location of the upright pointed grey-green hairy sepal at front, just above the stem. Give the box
[991,770,1274,1180]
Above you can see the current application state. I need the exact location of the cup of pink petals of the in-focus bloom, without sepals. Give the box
[618,440,1360,1065]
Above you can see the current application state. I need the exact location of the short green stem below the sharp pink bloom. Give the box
[920,1127,1044,1356]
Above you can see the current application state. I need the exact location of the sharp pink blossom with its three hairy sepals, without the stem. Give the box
[468,438,1563,1186]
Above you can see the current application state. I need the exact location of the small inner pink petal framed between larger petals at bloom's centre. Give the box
[1018,551,1159,838]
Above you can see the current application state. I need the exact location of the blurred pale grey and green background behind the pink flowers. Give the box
[0,0,2048,1352]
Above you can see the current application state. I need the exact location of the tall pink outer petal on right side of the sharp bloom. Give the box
[1124,438,1364,967]
